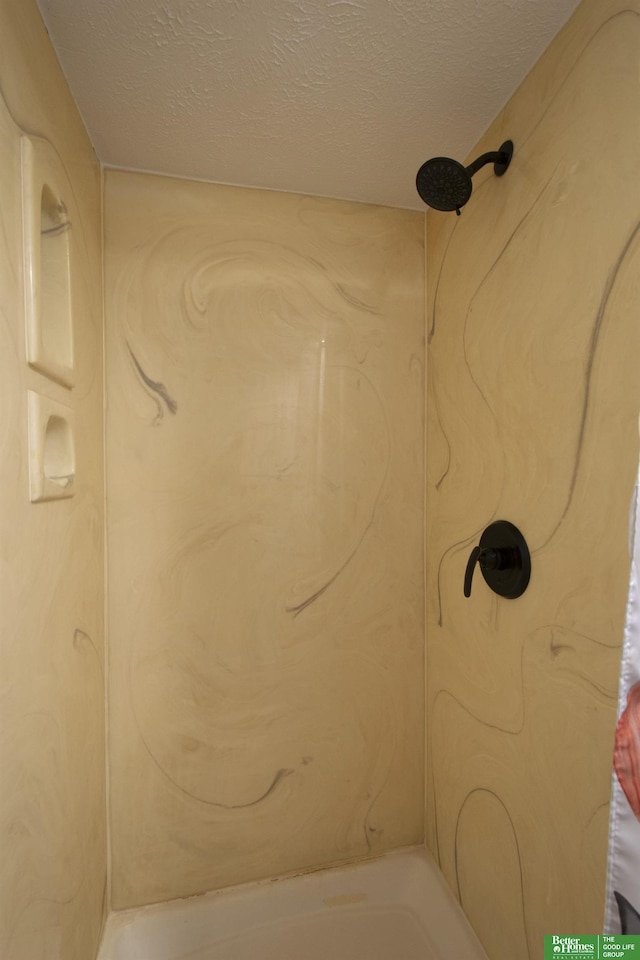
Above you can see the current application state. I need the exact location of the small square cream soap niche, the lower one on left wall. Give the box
[27,390,76,503]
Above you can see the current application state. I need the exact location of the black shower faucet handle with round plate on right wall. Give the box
[464,520,531,600]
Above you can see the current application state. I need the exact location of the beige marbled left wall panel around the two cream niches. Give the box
[0,0,106,960]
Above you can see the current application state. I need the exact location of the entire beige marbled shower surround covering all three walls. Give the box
[0,0,640,960]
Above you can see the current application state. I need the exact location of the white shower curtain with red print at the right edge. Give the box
[605,438,640,934]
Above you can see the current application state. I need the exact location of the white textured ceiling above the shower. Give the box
[39,0,577,209]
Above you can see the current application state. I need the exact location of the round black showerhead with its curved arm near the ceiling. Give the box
[416,140,513,215]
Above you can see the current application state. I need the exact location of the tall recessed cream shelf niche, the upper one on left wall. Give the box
[22,136,74,387]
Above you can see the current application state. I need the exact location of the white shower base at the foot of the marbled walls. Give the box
[98,848,488,960]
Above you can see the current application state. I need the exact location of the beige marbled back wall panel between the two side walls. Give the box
[106,172,424,907]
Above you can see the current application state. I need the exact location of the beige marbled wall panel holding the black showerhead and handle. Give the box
[427,0,640,960]
